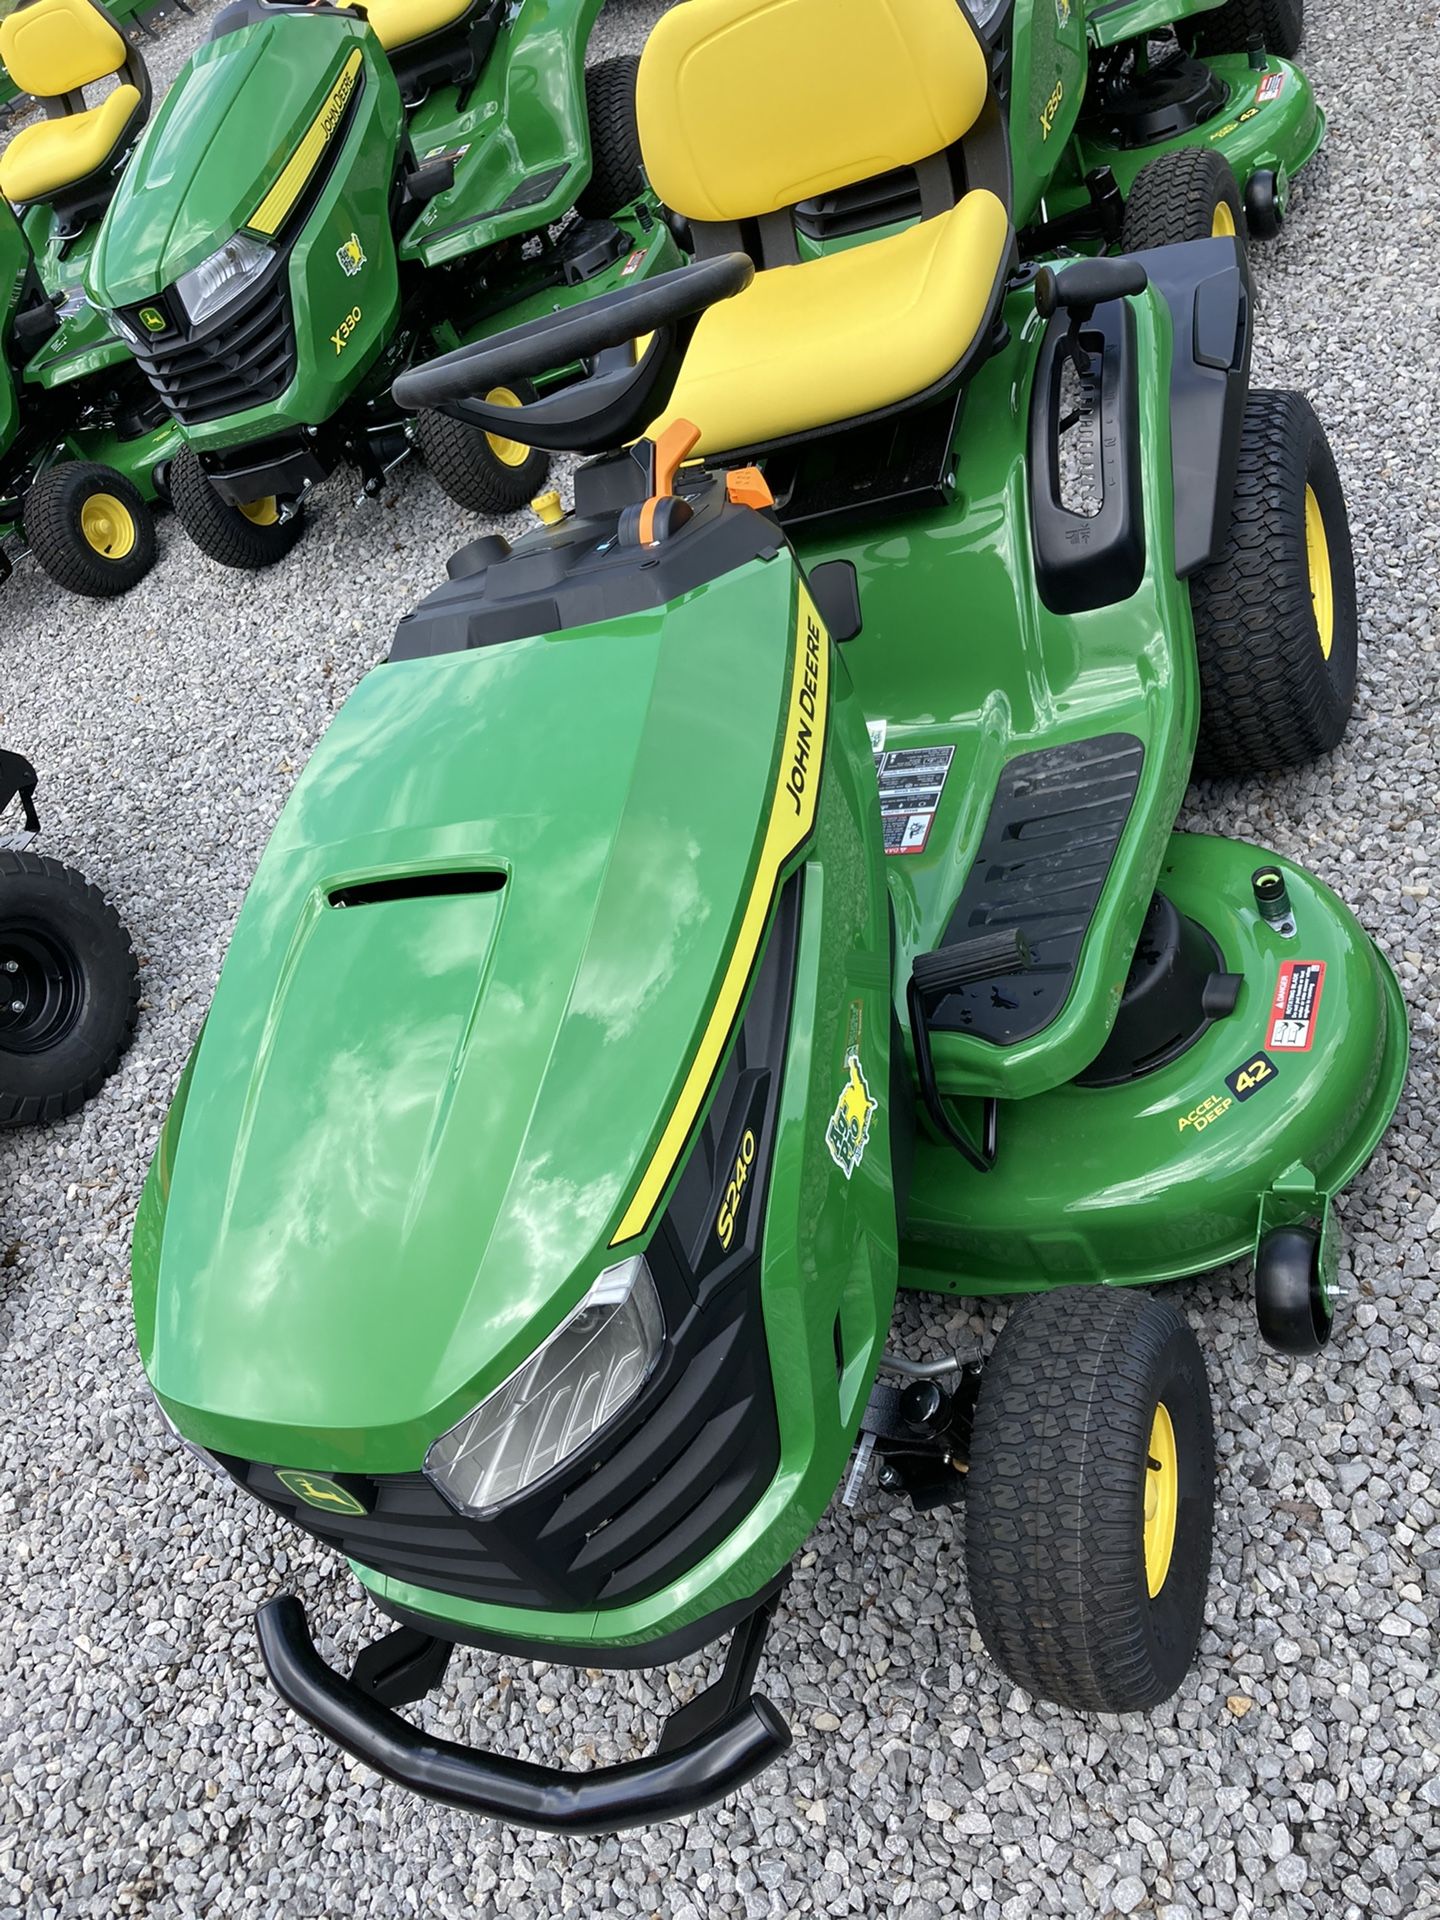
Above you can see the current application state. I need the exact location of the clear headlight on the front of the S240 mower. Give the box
[424,1256,664,1517]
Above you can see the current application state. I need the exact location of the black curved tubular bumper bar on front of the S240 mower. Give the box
[255,1594,791,1834]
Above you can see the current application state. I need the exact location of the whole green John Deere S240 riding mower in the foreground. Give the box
[134,0,1407,1832]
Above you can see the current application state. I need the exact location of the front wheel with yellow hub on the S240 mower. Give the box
[966,1286,1215,1713]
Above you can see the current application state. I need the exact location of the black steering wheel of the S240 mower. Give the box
[392,253,755,453]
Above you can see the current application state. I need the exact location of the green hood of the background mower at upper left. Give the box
[88,12,374,307]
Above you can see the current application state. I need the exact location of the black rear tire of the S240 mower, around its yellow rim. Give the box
[1190,388,1359,774]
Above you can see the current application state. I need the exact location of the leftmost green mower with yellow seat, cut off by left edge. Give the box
[0,0,179,597]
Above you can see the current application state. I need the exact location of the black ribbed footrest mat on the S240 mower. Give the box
[936,733,1144,1046]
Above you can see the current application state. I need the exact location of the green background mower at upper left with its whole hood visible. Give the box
[88,0,682,566]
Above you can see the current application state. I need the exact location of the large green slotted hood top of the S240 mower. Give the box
[136,559,795,1473]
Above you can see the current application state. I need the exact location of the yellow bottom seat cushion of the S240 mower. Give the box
[649,188,1012,455]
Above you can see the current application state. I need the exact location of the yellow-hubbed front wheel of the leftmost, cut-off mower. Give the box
[25,461,156,599]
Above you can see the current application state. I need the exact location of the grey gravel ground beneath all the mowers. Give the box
[0,0,1440,1920]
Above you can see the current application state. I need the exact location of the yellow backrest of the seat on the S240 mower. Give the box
[637,0,989,223]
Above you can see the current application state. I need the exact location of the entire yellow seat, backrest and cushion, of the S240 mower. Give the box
[637,0,1014,453]
